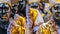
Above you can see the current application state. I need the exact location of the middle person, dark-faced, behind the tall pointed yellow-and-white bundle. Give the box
[28,3,44,34]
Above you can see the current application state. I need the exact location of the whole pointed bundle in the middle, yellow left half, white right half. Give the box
[29,8,44,25]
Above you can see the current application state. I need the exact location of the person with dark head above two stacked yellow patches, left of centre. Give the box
[8,0,26,34]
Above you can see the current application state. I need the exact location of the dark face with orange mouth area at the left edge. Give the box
[0,3,10,21]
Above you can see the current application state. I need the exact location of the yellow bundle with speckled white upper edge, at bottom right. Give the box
[36,21,55,34]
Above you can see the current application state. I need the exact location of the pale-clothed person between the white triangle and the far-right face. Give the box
[44,3,52,22]
